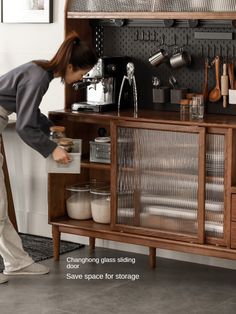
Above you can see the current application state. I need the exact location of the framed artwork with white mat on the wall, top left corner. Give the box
[1,0,53,23]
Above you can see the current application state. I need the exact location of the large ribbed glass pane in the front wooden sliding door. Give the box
[117,128,199,234]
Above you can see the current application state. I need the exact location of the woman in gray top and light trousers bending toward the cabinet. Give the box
[0,32,97,283]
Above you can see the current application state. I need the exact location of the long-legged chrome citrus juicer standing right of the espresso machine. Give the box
[118,62,138,118]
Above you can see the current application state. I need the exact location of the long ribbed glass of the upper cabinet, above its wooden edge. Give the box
[68,0,236,12]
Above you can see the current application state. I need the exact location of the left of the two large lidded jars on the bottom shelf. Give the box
[66,183,92,220]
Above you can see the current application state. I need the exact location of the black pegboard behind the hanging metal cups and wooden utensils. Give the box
[92,26,236,115]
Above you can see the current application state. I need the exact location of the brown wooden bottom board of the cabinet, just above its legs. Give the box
[50,217,236,260]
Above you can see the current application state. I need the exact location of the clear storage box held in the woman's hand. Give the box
[46,139,82,173]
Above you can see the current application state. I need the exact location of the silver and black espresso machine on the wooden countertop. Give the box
[71,57,128,112]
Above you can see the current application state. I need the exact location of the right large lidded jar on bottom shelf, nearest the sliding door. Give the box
[90,188,111,224]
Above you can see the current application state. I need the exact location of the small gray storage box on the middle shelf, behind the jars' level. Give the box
[89,141,111,164]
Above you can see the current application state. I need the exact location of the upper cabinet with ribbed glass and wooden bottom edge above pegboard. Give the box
[66,0,236,20]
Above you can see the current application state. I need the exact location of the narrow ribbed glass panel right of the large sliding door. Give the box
[205,134,225,238]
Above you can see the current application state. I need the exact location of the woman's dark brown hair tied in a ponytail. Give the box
[33,32,98,80]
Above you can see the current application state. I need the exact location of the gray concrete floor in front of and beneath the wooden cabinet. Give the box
[0,247,236,314]
